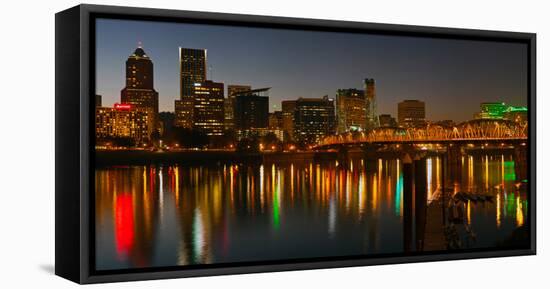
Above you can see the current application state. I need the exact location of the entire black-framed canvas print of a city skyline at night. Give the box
[55,5,536,283]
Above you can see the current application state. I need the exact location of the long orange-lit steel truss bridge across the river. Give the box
[316,120,528,149]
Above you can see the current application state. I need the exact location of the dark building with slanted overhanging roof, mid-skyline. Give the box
[234,88,269,131]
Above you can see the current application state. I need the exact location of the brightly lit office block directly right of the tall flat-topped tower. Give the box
[193,80,224,136]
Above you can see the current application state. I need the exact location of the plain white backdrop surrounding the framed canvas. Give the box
[0,0,550,289]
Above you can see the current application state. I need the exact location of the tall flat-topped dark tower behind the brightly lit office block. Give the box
[174,47,206,128]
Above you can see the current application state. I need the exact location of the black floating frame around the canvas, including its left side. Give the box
[55,4,536,284]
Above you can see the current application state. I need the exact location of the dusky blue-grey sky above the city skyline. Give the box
[96,19,527,121]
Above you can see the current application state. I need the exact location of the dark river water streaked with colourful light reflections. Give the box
[95,155,527,270]
